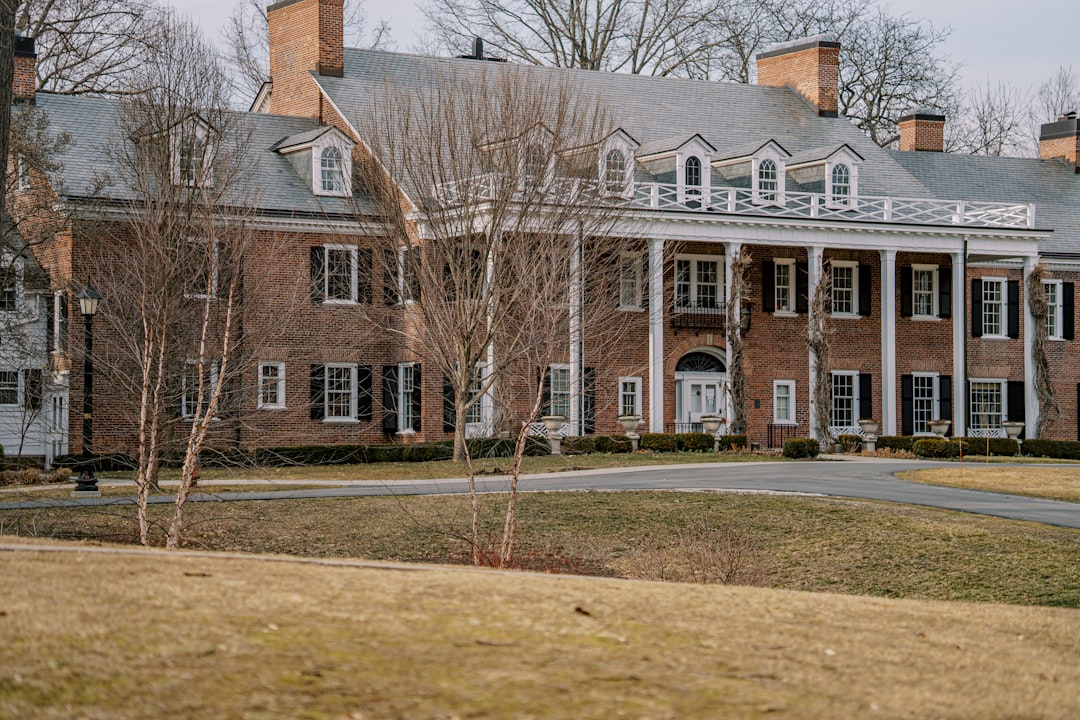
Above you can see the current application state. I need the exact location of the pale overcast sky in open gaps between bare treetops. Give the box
[187,0,1080,87]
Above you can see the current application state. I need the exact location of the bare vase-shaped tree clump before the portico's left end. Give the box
[359,66,629,562]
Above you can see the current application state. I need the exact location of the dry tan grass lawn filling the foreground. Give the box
[0,539,1080,720]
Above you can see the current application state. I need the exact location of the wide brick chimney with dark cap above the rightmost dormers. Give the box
[757,35,840,118]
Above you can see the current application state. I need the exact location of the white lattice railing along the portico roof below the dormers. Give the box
[434,174,1035,229]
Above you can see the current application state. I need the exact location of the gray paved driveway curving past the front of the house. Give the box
[0,458,1080,529]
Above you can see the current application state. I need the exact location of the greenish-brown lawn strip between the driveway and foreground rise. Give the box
[0,492,1080,608]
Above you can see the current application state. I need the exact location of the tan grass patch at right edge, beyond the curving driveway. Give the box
[897,464,1080,502]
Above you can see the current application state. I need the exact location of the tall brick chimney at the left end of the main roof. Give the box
[267,0,345,120]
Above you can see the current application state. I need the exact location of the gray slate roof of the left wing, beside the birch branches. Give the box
[37,93,372,216]
